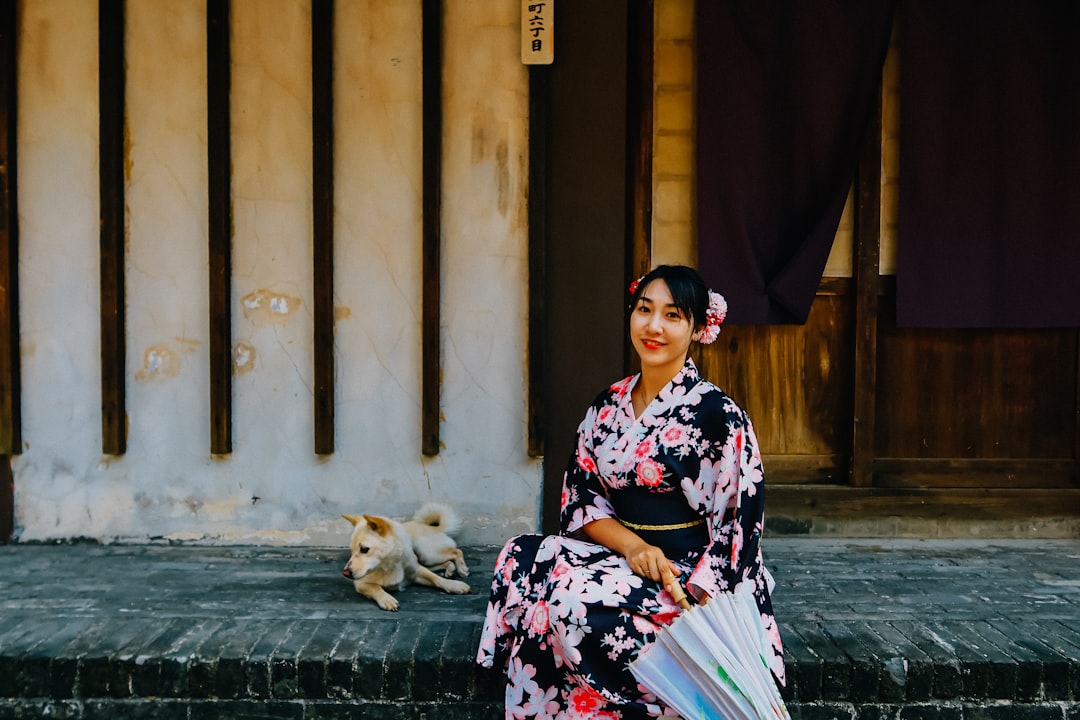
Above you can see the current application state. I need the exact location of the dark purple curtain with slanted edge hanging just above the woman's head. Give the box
[697,0,895,324]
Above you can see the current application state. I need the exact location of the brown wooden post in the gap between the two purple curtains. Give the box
[850,94,881,488]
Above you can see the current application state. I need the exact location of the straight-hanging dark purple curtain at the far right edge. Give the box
[896,0,1080,328]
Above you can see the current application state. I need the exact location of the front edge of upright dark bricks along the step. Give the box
[0,616,1080,718]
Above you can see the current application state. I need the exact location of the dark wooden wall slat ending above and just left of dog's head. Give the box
[311,0,334,454]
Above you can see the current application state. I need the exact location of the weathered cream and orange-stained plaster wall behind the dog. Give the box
[13,0,540,544]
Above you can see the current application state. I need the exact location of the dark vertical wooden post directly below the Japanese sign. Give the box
[527,65,551,458]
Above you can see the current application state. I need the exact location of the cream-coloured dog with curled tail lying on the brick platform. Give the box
[341,503,471,612]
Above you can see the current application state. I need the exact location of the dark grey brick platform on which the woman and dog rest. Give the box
[0,538,1080,720]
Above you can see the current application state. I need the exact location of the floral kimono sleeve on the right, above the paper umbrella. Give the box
[688,400,765,598]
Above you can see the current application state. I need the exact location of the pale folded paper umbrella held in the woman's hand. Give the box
[630,575,791,720]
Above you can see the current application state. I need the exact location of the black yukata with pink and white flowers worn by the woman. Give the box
[476,359,784,720]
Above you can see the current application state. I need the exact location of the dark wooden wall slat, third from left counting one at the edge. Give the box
[206,0,232,454]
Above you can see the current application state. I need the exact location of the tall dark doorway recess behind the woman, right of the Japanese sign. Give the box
[541,0,638,532]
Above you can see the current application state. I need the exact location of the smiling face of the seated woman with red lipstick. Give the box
[630,280,694,377]
